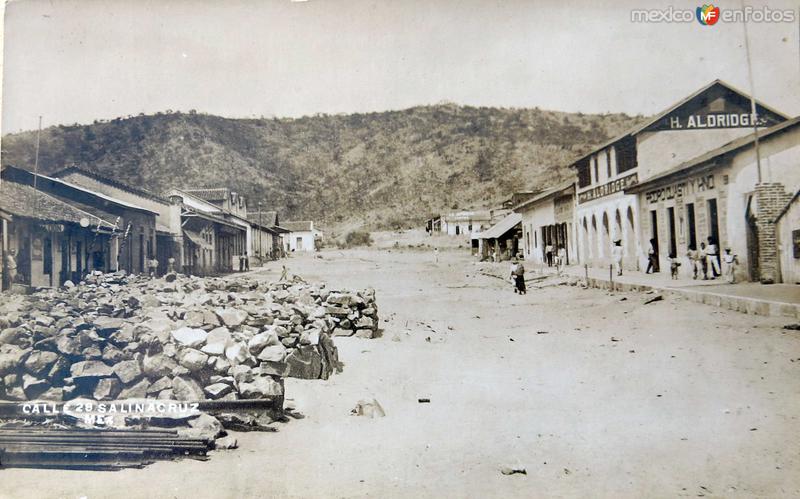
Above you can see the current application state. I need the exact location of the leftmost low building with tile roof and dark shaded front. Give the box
[0,179,122,290]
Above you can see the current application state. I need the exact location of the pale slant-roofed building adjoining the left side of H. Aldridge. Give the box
[514,180,579,265]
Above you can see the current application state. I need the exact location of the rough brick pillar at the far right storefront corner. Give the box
[756,182,791,284]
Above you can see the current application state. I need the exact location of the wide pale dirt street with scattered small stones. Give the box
[0,250,800,498]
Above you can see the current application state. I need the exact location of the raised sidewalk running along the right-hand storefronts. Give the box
[529,265,800,319]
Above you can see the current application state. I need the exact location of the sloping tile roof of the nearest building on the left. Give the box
[0,180,116,228]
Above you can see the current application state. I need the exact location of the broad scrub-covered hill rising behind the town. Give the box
[2,104,637,228]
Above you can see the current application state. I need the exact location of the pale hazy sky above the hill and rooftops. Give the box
[2,0,800,133]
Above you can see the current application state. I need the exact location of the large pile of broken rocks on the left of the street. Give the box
[0,272,378,401]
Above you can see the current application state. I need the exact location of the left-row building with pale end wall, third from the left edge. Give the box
[53,166,183,273]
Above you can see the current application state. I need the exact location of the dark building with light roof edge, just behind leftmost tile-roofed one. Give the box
[2,166,157,275]
